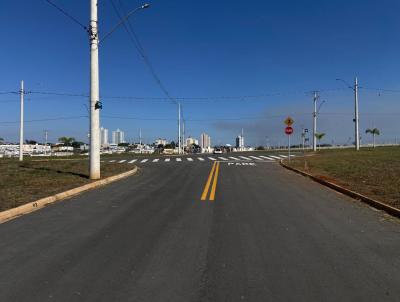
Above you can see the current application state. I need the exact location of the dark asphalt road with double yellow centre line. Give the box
[0,157,400,302]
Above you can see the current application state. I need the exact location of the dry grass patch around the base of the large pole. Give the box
[0,159,133,211]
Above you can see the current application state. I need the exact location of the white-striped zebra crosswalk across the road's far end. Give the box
[106,154,295,164]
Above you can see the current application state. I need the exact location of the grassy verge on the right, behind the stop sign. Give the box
[286,147,400,208]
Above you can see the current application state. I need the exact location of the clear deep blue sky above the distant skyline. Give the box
[0,0,400,145]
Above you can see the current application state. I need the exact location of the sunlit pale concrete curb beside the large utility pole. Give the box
[0,167,138,224]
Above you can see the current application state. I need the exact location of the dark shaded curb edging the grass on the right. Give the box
[280,160,400,218]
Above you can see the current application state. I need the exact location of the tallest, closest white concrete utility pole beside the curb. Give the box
[89,0,101,179]
